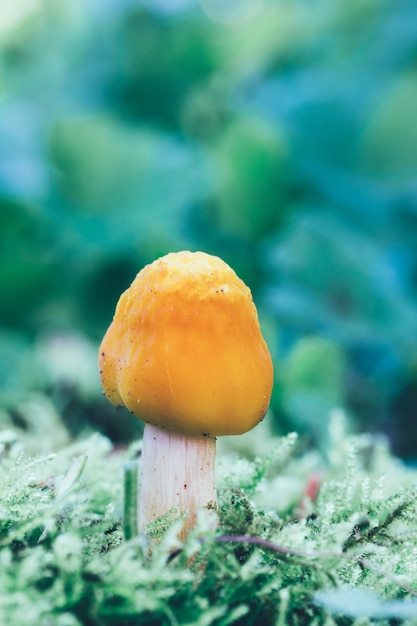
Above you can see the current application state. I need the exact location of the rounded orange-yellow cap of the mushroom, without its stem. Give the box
[99,251,273,436]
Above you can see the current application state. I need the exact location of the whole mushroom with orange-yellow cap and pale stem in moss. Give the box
[99,251,273,538]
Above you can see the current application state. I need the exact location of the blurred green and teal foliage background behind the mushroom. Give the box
[0,0,417,459]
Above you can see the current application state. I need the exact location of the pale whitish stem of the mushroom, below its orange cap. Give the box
[138,424,217,540]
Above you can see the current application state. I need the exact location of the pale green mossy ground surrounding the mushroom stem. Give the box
[0,414,417,626]
